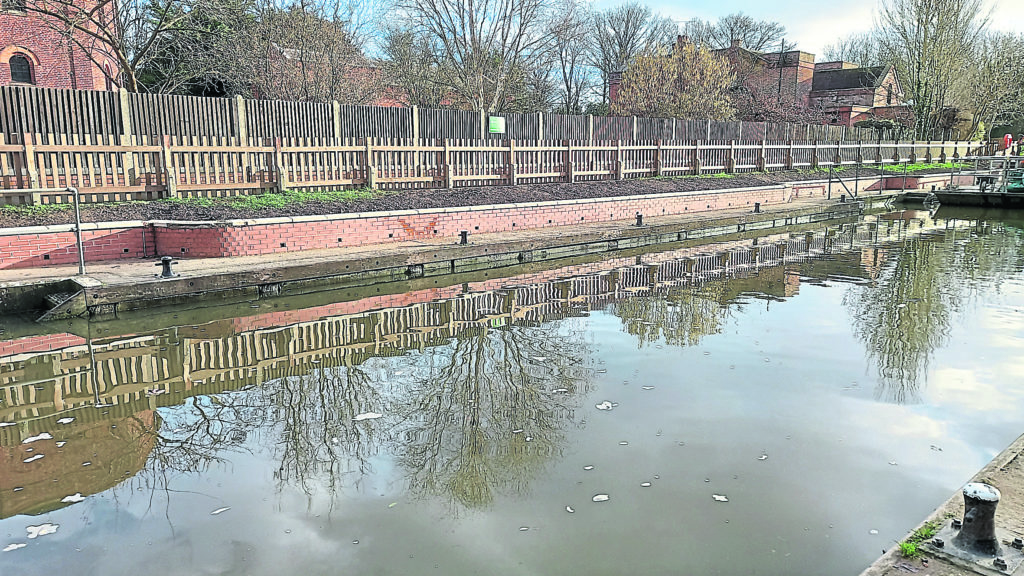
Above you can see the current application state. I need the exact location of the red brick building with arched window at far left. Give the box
[0,0,118,90]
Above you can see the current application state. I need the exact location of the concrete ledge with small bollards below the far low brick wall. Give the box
[0,195,891,320]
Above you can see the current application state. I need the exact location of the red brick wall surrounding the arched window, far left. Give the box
[0,7,117,90]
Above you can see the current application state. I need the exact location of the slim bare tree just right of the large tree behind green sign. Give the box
[547,0,594,114]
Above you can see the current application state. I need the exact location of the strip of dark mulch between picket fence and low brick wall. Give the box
[0,168,942,228]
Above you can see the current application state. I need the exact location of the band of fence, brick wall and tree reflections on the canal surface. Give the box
[0,207,1022,518]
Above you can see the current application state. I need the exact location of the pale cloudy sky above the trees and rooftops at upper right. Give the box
[592,0,1024,61]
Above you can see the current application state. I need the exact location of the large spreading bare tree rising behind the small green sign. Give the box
[398,0,546,112]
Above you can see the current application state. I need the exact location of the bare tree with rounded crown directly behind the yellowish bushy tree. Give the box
[590,2,679,102]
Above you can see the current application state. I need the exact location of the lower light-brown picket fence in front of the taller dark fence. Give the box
[0,134,982,204]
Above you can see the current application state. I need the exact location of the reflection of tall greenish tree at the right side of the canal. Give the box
[844,222,1022,404]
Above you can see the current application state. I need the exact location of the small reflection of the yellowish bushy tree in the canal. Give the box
[610,281,728,346]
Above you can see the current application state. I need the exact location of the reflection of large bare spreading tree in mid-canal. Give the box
[397,322,588,507]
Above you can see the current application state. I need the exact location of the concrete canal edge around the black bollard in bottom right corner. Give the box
[860,436,1024,576]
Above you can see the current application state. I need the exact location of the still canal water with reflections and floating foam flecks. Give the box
[0,204,1024,576]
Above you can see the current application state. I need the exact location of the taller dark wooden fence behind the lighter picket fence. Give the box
[0,86,877,145]
